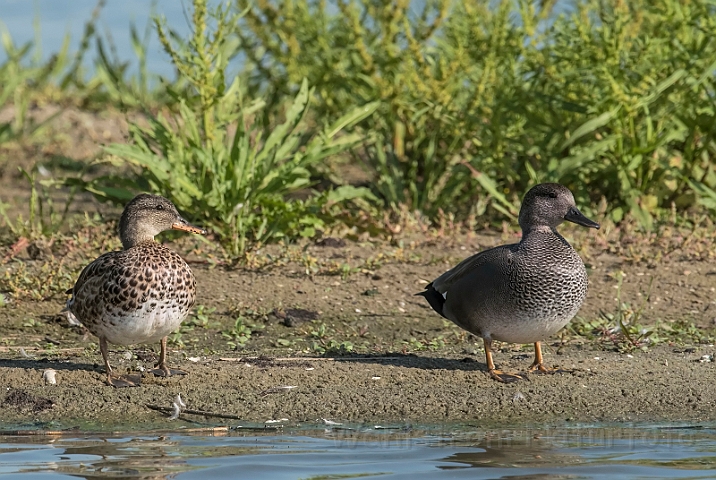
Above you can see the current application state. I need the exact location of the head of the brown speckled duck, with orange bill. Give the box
[119,193,206,249]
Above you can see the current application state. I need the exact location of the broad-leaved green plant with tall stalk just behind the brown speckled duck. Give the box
[88,0,377,255]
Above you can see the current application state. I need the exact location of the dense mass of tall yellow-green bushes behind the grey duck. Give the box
[235,0,716,229]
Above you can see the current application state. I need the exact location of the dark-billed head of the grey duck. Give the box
[520,183,599,231]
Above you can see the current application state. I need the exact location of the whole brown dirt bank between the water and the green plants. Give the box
[0,234,716,428]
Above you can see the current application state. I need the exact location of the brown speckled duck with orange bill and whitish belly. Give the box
[67,194,206,387]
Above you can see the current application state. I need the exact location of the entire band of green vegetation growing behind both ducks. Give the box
[0,0,716,242]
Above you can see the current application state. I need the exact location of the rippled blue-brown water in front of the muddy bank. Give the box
[0,425,716,479]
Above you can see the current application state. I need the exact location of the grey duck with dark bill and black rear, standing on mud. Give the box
[417,183,599,382]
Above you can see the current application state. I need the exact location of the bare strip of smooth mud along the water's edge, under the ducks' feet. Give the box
[0,345,716,430]
